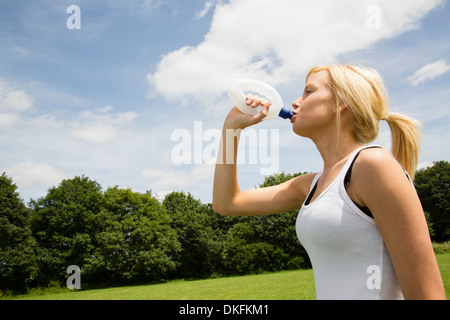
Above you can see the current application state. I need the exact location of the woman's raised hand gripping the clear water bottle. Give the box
[225,94,272,129]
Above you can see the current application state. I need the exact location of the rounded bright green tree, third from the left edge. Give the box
[86,187,180,284]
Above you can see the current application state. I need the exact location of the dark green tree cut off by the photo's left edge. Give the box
[0,173,38,292]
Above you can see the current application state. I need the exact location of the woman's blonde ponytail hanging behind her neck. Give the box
[384,113,422,180]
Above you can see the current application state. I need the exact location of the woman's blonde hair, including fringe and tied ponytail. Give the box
[306,65,421,179]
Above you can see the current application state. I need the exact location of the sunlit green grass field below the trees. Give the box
[7,253,450,300]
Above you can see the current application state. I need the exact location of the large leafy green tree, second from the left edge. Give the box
[30,176,103,285]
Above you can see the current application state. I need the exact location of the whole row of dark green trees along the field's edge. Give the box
[0,161,450,292]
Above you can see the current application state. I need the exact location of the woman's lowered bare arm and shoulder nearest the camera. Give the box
[351,149,445,300]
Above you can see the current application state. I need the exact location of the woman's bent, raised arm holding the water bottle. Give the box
[213,100,314,216]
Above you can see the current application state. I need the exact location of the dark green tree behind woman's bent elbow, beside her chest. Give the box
[222,173,311,274]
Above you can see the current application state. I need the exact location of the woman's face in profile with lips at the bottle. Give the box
[291,71,335,138]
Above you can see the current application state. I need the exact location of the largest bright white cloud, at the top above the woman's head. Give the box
[147,0,443,99]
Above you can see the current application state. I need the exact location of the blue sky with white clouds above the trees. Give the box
[0,0,450,203]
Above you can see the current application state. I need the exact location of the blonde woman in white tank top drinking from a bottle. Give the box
[213,65,445,299]
